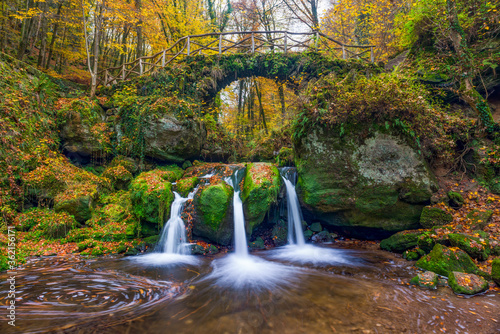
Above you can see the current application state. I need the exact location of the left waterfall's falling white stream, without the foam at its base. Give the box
[156,191,195,255]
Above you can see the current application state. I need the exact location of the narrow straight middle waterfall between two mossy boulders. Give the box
[226,171,248,257]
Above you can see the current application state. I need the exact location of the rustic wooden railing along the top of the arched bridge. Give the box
[98,30,374,86]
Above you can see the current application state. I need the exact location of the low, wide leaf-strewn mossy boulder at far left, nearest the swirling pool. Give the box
[15,208,78,239]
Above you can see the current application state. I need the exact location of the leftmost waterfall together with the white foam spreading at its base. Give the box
[131,188,198,265]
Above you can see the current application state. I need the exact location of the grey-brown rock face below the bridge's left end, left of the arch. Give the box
[144,115,207,162]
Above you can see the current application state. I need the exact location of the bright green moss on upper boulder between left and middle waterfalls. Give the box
[198,182,233,231]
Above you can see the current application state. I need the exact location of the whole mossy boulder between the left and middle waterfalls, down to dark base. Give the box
[193,181,233,245]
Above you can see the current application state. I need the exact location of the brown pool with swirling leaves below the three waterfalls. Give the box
[0,246,500,334]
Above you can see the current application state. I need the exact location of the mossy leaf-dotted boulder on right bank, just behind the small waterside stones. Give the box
[415,244,478,277]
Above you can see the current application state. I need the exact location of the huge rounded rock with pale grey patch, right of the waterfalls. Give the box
[294,126,437,238]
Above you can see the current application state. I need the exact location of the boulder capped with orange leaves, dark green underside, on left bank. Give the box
[54,184,99,223]
